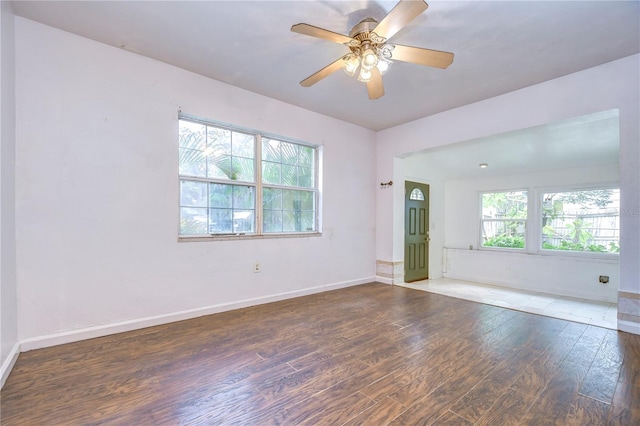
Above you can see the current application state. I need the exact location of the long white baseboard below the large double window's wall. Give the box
[20,277,377,352]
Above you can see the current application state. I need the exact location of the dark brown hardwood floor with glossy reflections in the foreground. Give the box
[1,283,640,426]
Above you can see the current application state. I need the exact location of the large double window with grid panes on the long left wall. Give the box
[178,117,319,236]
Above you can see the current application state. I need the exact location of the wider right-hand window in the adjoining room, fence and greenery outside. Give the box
[542,189,620,253]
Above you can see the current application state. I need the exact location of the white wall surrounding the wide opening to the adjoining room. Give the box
[376,55,640,332]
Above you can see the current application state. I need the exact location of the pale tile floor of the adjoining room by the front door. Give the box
[397,278,618,330]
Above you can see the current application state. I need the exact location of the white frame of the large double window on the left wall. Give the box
[174,112,322,242]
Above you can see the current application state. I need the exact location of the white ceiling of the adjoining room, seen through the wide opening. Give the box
[410,110,620,180]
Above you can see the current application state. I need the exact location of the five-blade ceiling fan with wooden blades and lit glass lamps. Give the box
[291,0,453,99]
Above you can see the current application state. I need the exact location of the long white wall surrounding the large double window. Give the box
[16,18,376,349]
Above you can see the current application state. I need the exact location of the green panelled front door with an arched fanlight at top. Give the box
[404,181,429,282]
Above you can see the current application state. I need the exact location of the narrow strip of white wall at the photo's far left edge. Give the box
[0,1,18,386]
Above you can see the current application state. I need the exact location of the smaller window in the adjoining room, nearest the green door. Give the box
[480,191,527,249]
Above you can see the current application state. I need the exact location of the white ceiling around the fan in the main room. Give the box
[12,0,640,130]
